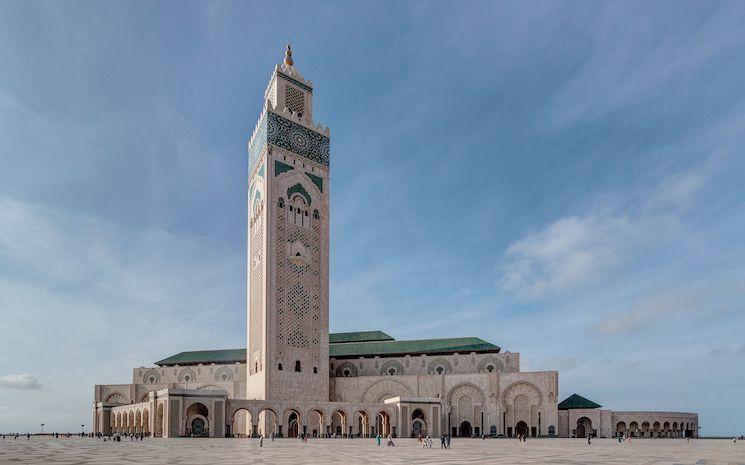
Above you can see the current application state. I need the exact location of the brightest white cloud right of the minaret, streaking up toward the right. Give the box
[501,153,722,298]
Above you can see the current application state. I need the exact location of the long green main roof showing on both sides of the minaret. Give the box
[155,331,501,366]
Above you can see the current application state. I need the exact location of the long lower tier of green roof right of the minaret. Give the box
[329,337,500,358]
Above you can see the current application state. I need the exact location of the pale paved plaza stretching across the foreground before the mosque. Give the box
[0,437,745,465]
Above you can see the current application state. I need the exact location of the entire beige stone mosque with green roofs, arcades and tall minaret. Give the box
[93,45,698,437]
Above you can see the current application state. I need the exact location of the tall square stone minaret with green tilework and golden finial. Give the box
[246,45,330,402]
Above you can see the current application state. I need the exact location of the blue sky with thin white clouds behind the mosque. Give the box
[0,1,745,435]
